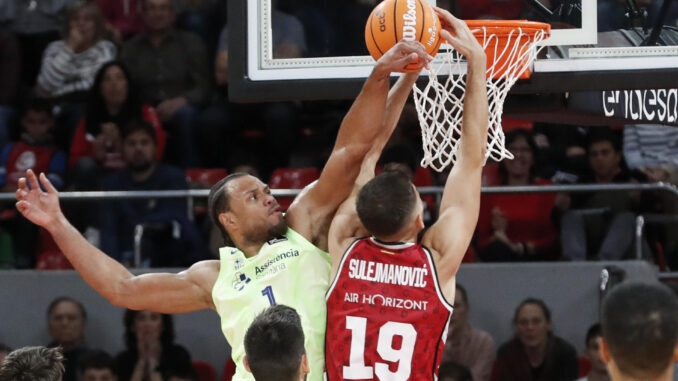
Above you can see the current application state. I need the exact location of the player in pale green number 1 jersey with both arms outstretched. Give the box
[16,42,432,381]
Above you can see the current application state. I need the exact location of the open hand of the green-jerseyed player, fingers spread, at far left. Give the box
[16,169,61,230]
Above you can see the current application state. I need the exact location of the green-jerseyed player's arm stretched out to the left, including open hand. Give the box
[16,169,219,313]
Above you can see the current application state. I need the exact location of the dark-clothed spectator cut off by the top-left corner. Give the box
[0,0,77,88]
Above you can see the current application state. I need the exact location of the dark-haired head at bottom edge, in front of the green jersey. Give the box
[244,304,309,381]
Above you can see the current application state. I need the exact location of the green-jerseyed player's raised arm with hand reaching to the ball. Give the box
[287,41,432,249]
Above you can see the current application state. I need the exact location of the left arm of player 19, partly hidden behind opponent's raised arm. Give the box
[329,71,419,270]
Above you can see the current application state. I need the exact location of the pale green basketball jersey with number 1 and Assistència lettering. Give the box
[212,229,331,381]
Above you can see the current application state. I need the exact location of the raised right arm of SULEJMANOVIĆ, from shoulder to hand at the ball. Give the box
[423,8,489,277]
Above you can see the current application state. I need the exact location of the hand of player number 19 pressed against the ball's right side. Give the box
[433,7,486,66]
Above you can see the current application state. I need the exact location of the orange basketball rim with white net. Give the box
[414,20,551,172]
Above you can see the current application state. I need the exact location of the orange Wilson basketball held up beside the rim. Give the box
[365,0,440,71]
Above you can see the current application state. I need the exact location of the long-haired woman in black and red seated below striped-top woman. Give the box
[68,61,165,190]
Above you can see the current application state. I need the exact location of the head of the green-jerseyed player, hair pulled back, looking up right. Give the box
[208,173,287,242]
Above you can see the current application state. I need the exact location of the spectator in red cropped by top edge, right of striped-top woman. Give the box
[96,0,144,44]
